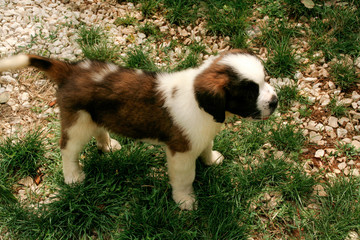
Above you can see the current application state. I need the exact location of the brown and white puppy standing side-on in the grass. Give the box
[0,50,278,210]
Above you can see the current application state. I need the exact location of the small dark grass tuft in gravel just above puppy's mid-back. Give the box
[123,48,158,72]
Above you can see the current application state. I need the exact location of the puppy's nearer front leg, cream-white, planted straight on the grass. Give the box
[166,148,196,210]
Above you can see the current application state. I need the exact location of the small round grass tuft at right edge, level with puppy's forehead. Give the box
[330,61,359,92]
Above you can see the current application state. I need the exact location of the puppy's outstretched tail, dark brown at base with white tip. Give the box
[0,54,72,85]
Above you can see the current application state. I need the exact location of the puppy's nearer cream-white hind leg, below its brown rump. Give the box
[61,111,98,184]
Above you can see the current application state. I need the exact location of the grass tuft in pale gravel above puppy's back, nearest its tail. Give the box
[77,26,119,62]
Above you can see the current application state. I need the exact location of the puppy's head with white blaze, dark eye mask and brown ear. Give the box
[195,50,278,122]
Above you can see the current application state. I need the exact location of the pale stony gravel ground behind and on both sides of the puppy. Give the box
[0,0,360,180]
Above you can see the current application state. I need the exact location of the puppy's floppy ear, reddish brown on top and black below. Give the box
[194,65,229,123]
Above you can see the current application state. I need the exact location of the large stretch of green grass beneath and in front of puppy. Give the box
[0,118,359,239]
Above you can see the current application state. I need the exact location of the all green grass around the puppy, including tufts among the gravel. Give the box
[0,0,360,237]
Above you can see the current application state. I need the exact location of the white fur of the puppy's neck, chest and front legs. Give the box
[158,69,223,210]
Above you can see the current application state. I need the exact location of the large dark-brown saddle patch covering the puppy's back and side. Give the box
[57,62,190,152]
